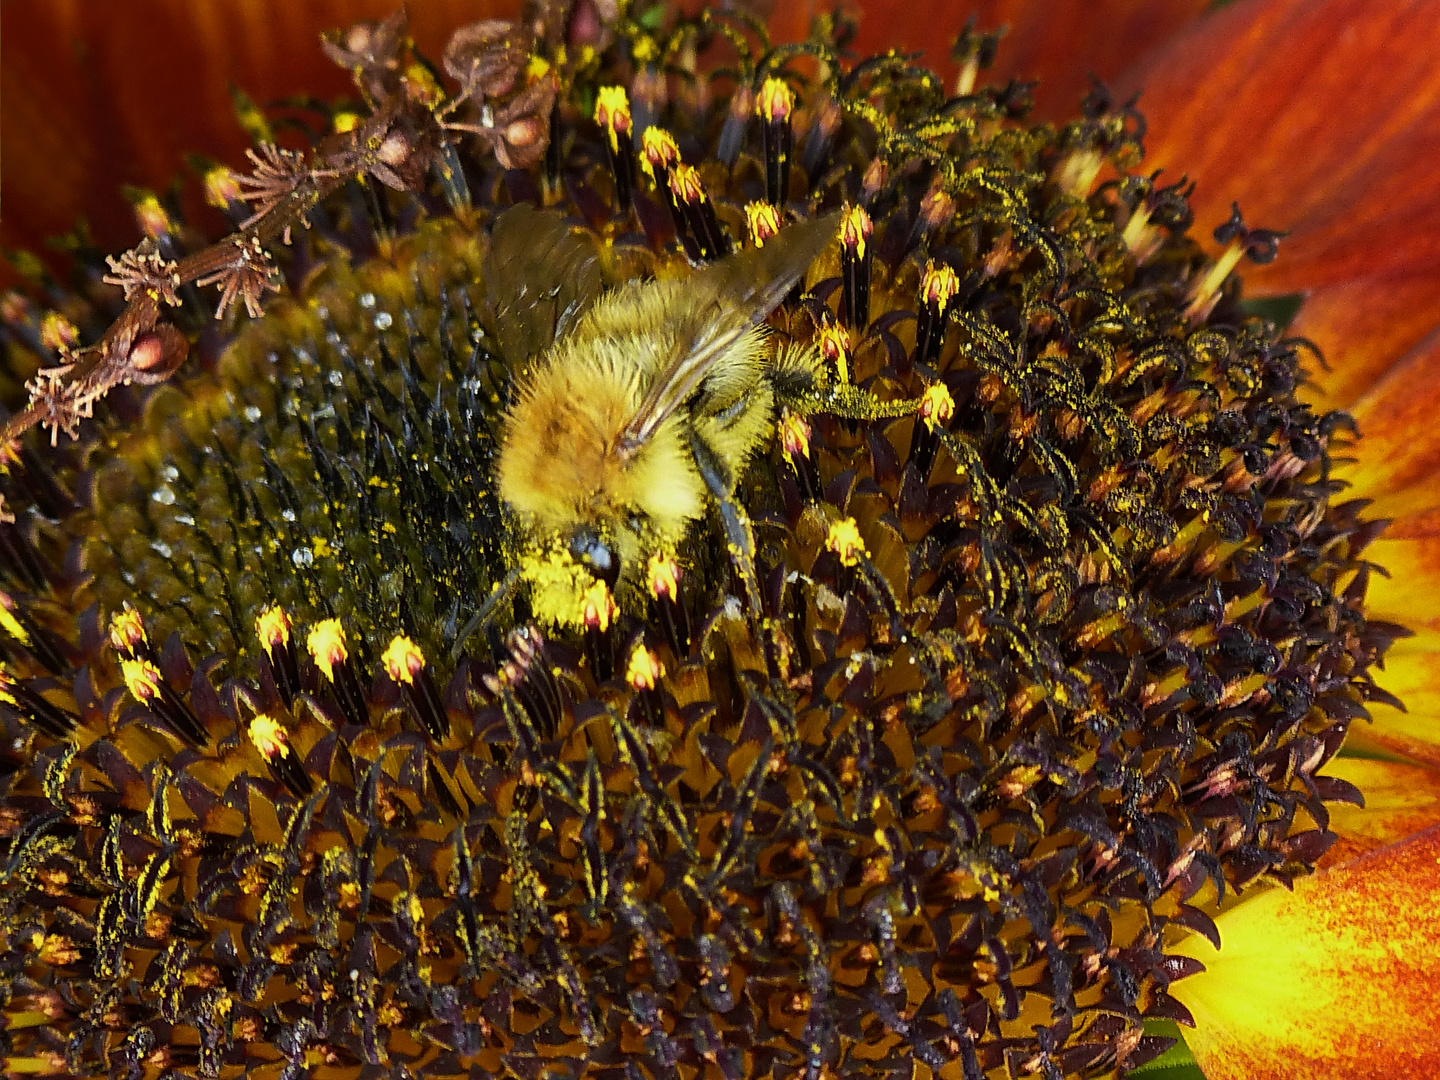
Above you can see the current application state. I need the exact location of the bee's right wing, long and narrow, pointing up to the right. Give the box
[621,213,840,449]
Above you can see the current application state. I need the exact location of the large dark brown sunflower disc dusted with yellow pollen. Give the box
[0,2,1397,1080]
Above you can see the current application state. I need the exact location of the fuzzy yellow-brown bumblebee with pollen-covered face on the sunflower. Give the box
[487,206,838,625]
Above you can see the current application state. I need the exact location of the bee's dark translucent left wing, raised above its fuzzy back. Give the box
[484,203,605,369]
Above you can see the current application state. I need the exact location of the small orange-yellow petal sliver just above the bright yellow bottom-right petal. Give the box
[1320,757,1440,867]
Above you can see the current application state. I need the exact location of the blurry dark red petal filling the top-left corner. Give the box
[0,0,520,260]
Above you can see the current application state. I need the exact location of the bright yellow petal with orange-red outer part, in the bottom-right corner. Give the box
[1171,828,1440,1080]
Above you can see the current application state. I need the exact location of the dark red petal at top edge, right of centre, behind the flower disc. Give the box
[840,0,1210,120]
